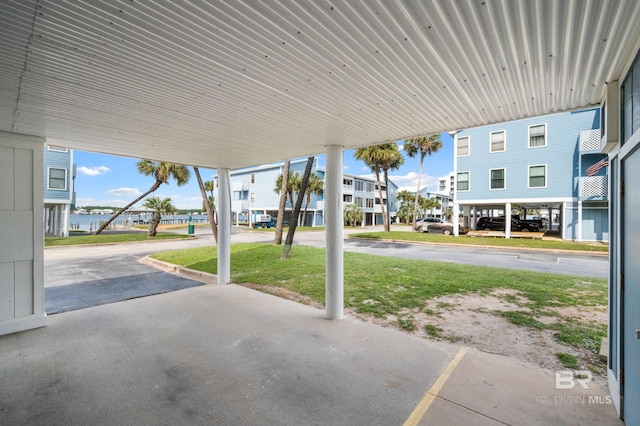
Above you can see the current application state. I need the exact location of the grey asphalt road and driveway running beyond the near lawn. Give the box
[44,228,609,314]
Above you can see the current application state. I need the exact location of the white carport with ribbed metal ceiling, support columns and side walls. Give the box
[0,0,640,423]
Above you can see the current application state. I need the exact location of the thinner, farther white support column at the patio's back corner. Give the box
[218,169,231,284]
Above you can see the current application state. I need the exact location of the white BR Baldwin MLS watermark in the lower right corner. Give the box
[536,370,613,405]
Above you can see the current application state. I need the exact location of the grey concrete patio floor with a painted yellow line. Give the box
[0,285,622,425]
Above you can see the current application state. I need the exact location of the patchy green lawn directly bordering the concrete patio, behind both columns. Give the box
[153,243,607,352]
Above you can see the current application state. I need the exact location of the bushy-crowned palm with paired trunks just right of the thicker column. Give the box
[354,142,404,232]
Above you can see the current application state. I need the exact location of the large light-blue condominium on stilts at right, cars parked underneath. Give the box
[454,108,609,241]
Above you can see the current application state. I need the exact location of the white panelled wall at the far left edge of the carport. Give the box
[0,132,45,335]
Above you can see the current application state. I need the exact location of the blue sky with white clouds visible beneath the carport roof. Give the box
[74,133,453,210]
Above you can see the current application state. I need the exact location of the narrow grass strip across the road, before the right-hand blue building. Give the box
[349,231,609,253]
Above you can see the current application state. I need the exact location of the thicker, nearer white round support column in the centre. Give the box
[325,145,344,319]
